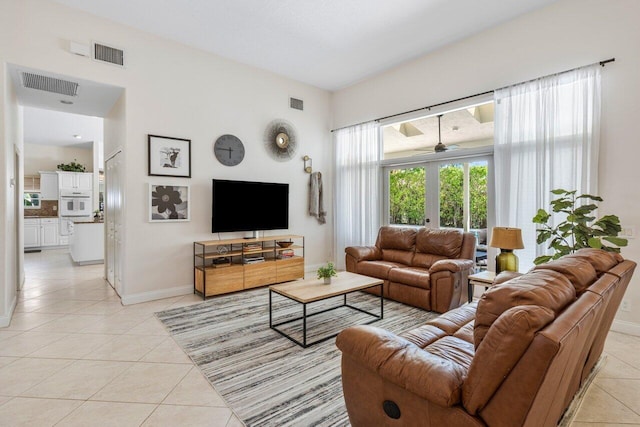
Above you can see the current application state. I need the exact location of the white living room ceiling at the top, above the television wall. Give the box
[55,0,557,91]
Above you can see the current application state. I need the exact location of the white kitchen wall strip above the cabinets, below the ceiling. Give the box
[24,144,94,175]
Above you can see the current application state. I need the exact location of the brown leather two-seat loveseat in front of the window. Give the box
[345,226,476,313]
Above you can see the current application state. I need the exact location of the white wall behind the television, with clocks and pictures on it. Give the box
[0,0,332,310]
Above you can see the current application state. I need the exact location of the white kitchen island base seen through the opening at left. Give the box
[69,221,104,265]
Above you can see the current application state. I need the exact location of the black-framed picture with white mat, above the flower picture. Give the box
[149,135,191,178]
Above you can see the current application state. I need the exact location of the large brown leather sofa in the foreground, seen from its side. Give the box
[336,249,636,427]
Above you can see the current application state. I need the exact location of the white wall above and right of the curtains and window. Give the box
[332,0,640,335]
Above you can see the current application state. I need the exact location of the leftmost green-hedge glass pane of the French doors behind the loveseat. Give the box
[389,167,425,225]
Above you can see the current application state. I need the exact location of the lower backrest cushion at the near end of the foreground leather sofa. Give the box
[462,305,555,415]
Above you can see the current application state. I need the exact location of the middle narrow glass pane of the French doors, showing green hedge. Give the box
[439,163,464,228]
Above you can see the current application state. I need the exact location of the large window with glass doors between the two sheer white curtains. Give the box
[381,101,494,268]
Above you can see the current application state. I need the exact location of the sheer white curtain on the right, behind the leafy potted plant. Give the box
[494,64,601,272]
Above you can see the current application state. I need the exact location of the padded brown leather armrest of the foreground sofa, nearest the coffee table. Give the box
[336,325,467,407]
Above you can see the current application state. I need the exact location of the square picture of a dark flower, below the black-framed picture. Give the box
[149,184,191,222]
